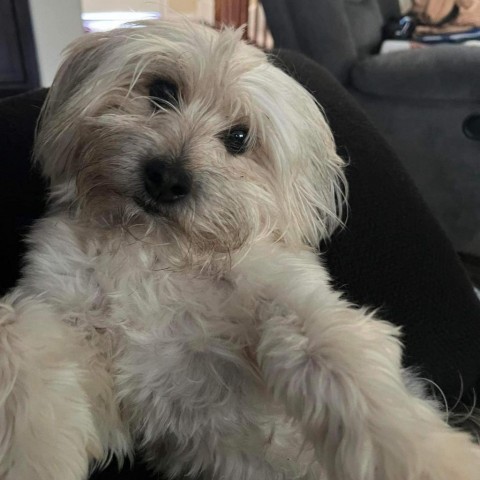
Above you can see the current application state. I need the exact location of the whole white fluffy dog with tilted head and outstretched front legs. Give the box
[0,21,480,480]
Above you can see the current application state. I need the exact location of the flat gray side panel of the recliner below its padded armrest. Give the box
[351,90,480,256]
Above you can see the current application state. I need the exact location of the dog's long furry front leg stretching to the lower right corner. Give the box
[233,245,480,480]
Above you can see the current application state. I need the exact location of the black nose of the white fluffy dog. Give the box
[144,159,192,203]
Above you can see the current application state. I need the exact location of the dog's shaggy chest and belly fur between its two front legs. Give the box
[23,218,265,443]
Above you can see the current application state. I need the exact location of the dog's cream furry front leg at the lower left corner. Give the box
[0,292,128,480]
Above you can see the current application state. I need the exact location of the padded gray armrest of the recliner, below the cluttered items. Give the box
[350,45,480,101]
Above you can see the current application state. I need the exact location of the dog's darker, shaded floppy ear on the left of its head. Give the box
[34,33,108,183]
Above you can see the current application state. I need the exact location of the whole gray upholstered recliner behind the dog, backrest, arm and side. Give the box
[263,0,480,257]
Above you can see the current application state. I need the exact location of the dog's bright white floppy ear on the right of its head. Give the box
[251,65,347,248]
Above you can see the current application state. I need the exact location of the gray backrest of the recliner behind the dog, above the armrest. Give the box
[262,0,399,83]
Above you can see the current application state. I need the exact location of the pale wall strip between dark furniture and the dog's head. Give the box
[29,0,83,87]
